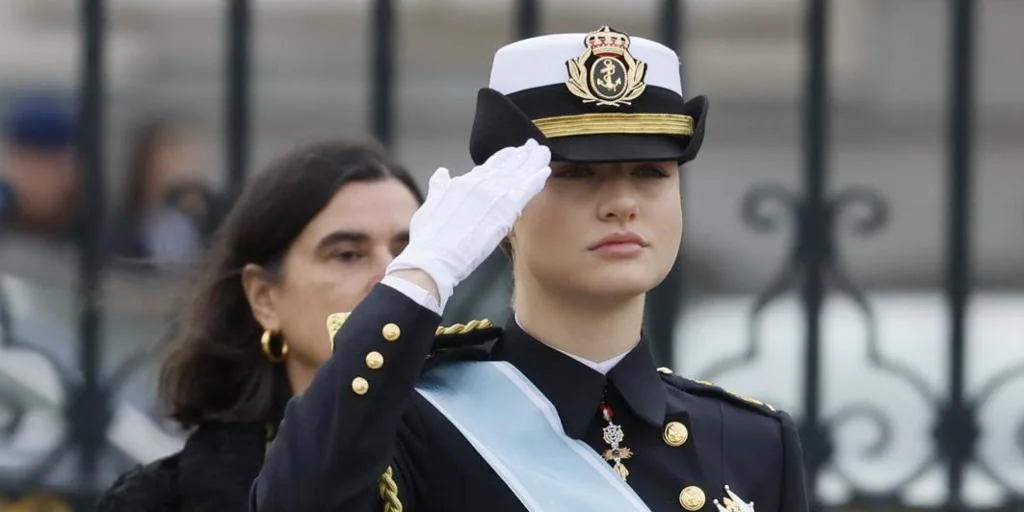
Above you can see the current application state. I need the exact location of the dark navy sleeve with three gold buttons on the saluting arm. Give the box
[251,285,440,512]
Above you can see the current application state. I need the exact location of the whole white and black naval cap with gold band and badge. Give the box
[469,25,708,164]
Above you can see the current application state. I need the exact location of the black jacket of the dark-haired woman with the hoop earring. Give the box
[96,423,267,512]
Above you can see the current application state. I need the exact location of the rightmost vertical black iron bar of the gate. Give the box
[946,0,975,503]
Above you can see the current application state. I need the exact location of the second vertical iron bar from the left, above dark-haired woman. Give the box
[224,0,252,201]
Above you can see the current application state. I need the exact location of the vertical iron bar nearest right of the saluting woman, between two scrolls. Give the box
[799,0,830,497]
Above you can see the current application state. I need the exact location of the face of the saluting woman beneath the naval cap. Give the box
[509,162,683,300]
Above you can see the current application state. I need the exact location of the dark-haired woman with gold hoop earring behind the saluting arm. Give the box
[92,140,422,512]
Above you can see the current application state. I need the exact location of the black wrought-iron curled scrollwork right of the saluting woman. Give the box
[698,171,1024,504]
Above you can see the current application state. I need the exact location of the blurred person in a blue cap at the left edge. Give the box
[0,89,82,365]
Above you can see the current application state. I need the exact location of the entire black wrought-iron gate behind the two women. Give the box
[0,0,1024,511]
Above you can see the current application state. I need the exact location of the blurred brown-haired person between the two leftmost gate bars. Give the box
[113,116,219,270]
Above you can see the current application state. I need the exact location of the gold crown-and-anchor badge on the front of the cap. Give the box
[565,26,647,106]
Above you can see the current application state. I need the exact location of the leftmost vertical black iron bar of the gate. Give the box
[75,0,106,488]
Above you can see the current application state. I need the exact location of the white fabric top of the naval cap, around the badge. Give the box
[488,34,683,96]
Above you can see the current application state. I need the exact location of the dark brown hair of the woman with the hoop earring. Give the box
[160,140,423,428]
